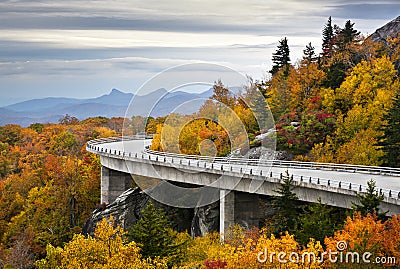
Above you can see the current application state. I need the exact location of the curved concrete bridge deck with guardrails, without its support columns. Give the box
[87,137,400,214]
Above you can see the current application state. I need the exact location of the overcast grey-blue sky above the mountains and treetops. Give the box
[0,0,400,106]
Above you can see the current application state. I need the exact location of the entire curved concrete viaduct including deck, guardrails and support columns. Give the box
[86,137,400,232]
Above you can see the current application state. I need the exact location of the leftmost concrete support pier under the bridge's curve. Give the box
[100,166,132,204]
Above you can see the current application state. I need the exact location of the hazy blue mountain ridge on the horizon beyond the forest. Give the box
[0,88,212,126]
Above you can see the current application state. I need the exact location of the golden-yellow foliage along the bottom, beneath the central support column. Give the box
[180,226,323,269]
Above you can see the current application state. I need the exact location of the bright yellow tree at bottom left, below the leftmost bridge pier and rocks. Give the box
[36,217,167,269]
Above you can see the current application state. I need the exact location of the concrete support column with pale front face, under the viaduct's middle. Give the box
[219,190,260,240]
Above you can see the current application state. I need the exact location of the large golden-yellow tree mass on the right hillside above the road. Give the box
[313,57,400,165]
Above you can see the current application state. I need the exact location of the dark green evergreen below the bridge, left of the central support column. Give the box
[128,204,179,260]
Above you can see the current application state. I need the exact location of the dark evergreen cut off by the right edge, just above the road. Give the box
[378,94,400,167]
